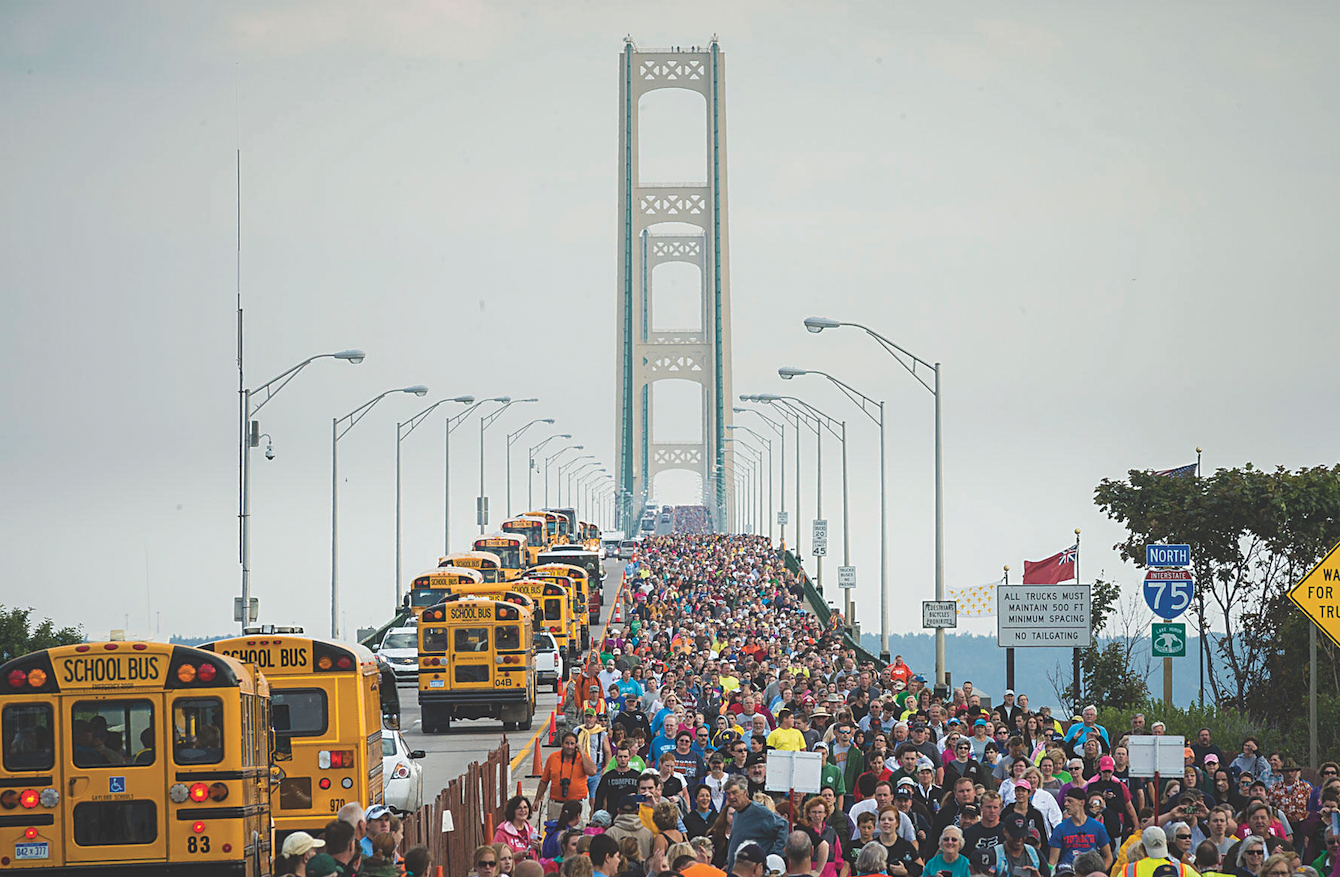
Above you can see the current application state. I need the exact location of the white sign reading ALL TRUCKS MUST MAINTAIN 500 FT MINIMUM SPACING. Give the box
[996,585,1093,649]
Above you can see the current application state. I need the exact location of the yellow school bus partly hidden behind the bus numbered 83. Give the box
[200,633,385,849]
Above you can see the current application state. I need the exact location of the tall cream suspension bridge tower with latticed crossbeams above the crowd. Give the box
[615,38,734,532]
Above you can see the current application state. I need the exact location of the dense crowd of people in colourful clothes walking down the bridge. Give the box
[485,535,1340,877]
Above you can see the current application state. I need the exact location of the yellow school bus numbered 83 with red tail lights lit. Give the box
[0,641,273,877]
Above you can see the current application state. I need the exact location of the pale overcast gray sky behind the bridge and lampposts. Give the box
[0,0,1340,646]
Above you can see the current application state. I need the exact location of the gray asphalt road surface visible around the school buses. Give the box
[399,561,624,803]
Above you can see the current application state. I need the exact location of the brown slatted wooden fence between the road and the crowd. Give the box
[401,735,511,874]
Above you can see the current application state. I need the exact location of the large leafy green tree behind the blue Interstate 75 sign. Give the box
[1093,463,1340,724]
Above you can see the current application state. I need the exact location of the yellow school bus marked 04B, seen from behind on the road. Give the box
[418,594,536,734]
